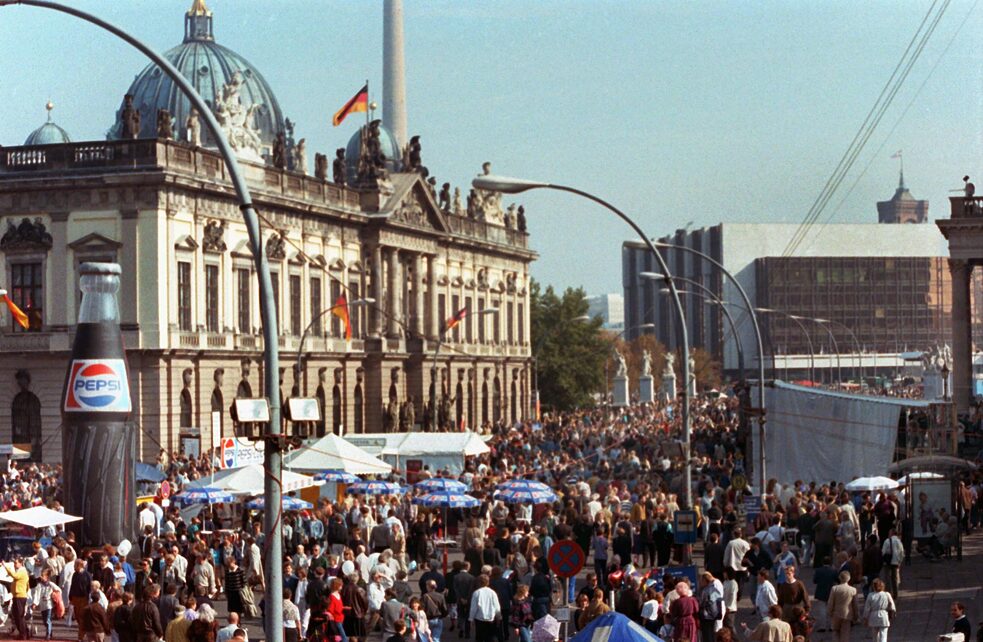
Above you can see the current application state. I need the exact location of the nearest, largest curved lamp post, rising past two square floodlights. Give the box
[0,0,283,642]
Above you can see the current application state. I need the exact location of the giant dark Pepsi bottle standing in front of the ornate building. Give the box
[61,263,136,546]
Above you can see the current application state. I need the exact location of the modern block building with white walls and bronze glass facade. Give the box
[622,181,983,380]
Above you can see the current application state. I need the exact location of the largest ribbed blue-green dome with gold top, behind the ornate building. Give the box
[108,0,285,152]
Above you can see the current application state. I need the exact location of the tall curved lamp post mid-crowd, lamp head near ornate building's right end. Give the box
[471,175,693,509]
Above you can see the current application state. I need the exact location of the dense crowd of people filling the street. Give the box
[0,396,983,642]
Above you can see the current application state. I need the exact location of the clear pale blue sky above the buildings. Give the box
[0,0,983,294]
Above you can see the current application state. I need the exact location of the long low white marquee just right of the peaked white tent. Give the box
[345,431,490,475]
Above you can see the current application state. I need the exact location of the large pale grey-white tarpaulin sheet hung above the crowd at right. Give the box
[751,381,928,483]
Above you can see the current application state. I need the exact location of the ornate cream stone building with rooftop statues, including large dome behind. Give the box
[0,0,535,461]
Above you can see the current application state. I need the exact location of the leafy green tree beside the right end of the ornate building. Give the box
[529,280,608,410]
